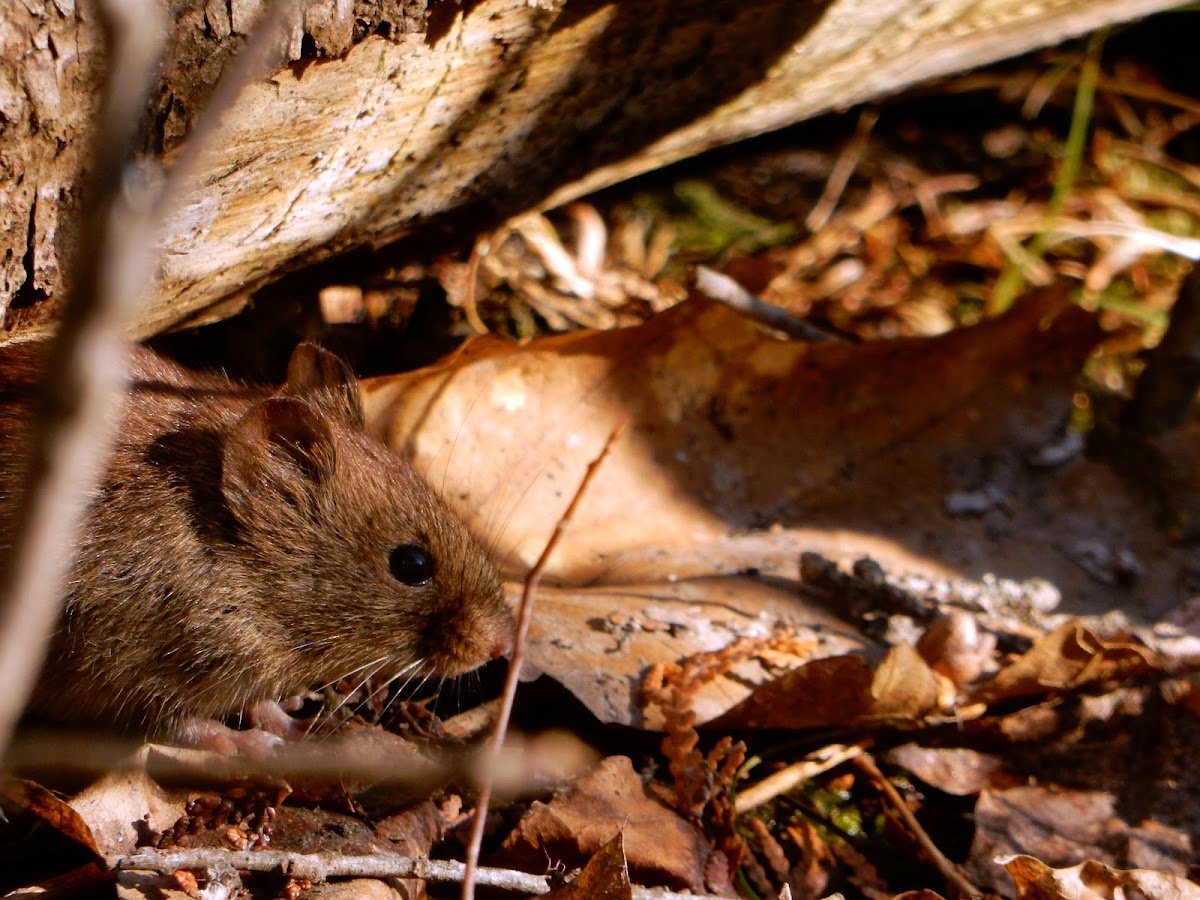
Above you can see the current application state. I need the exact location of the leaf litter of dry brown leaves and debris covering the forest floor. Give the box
[4,12,1200,900]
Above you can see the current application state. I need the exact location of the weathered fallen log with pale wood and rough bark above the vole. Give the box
[0,0,1174,340]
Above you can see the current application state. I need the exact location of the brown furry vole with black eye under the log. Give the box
[0,343,511,750]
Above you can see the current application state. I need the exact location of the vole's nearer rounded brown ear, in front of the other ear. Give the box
[221,397,337,517]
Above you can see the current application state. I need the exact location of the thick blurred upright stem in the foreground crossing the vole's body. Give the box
[0,0,166,763]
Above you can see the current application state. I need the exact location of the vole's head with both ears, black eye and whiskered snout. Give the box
[221,344,512,682]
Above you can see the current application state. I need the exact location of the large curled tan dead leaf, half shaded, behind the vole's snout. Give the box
[365,290,1098,600]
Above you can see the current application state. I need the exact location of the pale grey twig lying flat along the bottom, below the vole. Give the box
[106,847,715,900]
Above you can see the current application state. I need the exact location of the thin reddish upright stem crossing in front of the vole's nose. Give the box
[462,424,625,900]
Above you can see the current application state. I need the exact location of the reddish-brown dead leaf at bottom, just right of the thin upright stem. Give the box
[500,756,708,892]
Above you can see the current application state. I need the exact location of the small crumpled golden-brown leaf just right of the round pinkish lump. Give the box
[972,622,1154,702]
